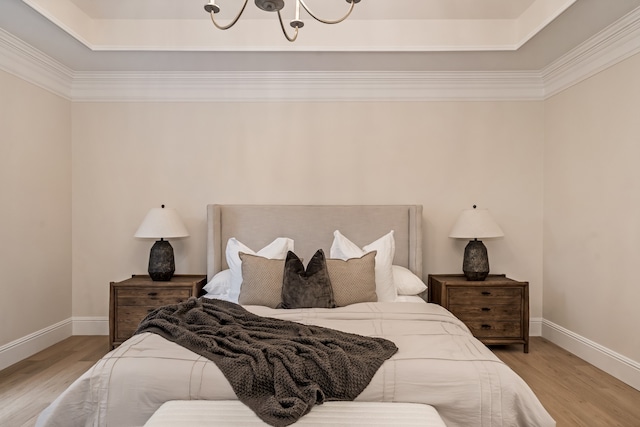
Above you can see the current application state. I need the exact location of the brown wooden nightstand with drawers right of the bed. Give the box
[428,274,529,353]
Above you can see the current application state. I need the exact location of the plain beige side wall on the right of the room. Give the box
[543,51,640,361]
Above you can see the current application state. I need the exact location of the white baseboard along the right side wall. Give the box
[542,319,640,390]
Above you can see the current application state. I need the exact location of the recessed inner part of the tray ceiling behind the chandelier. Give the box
[23,0,576,52]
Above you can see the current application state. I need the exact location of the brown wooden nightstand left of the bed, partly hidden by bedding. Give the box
[109,274,207,348]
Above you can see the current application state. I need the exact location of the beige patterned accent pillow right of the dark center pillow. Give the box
[327,251,378,307]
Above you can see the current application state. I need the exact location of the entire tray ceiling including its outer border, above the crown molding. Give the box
[0,0,640,73]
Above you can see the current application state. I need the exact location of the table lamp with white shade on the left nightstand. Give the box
[134,205,189,282]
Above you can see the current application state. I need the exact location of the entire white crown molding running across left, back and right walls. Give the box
[0,9,640,102]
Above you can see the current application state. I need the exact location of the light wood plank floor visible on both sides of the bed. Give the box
[0,336,640,427]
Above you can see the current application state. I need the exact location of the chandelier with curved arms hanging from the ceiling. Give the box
[204,0,360,42]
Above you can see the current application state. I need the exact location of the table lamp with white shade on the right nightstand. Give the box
[449,205,504,281]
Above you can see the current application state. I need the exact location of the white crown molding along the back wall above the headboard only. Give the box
[72,71,544,102]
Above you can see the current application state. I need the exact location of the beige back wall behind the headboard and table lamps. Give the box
[73,102,544,317]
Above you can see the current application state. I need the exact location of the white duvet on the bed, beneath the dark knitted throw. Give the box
[36,302,555,427]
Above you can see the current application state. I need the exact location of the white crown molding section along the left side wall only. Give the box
[0,29,73,99]
